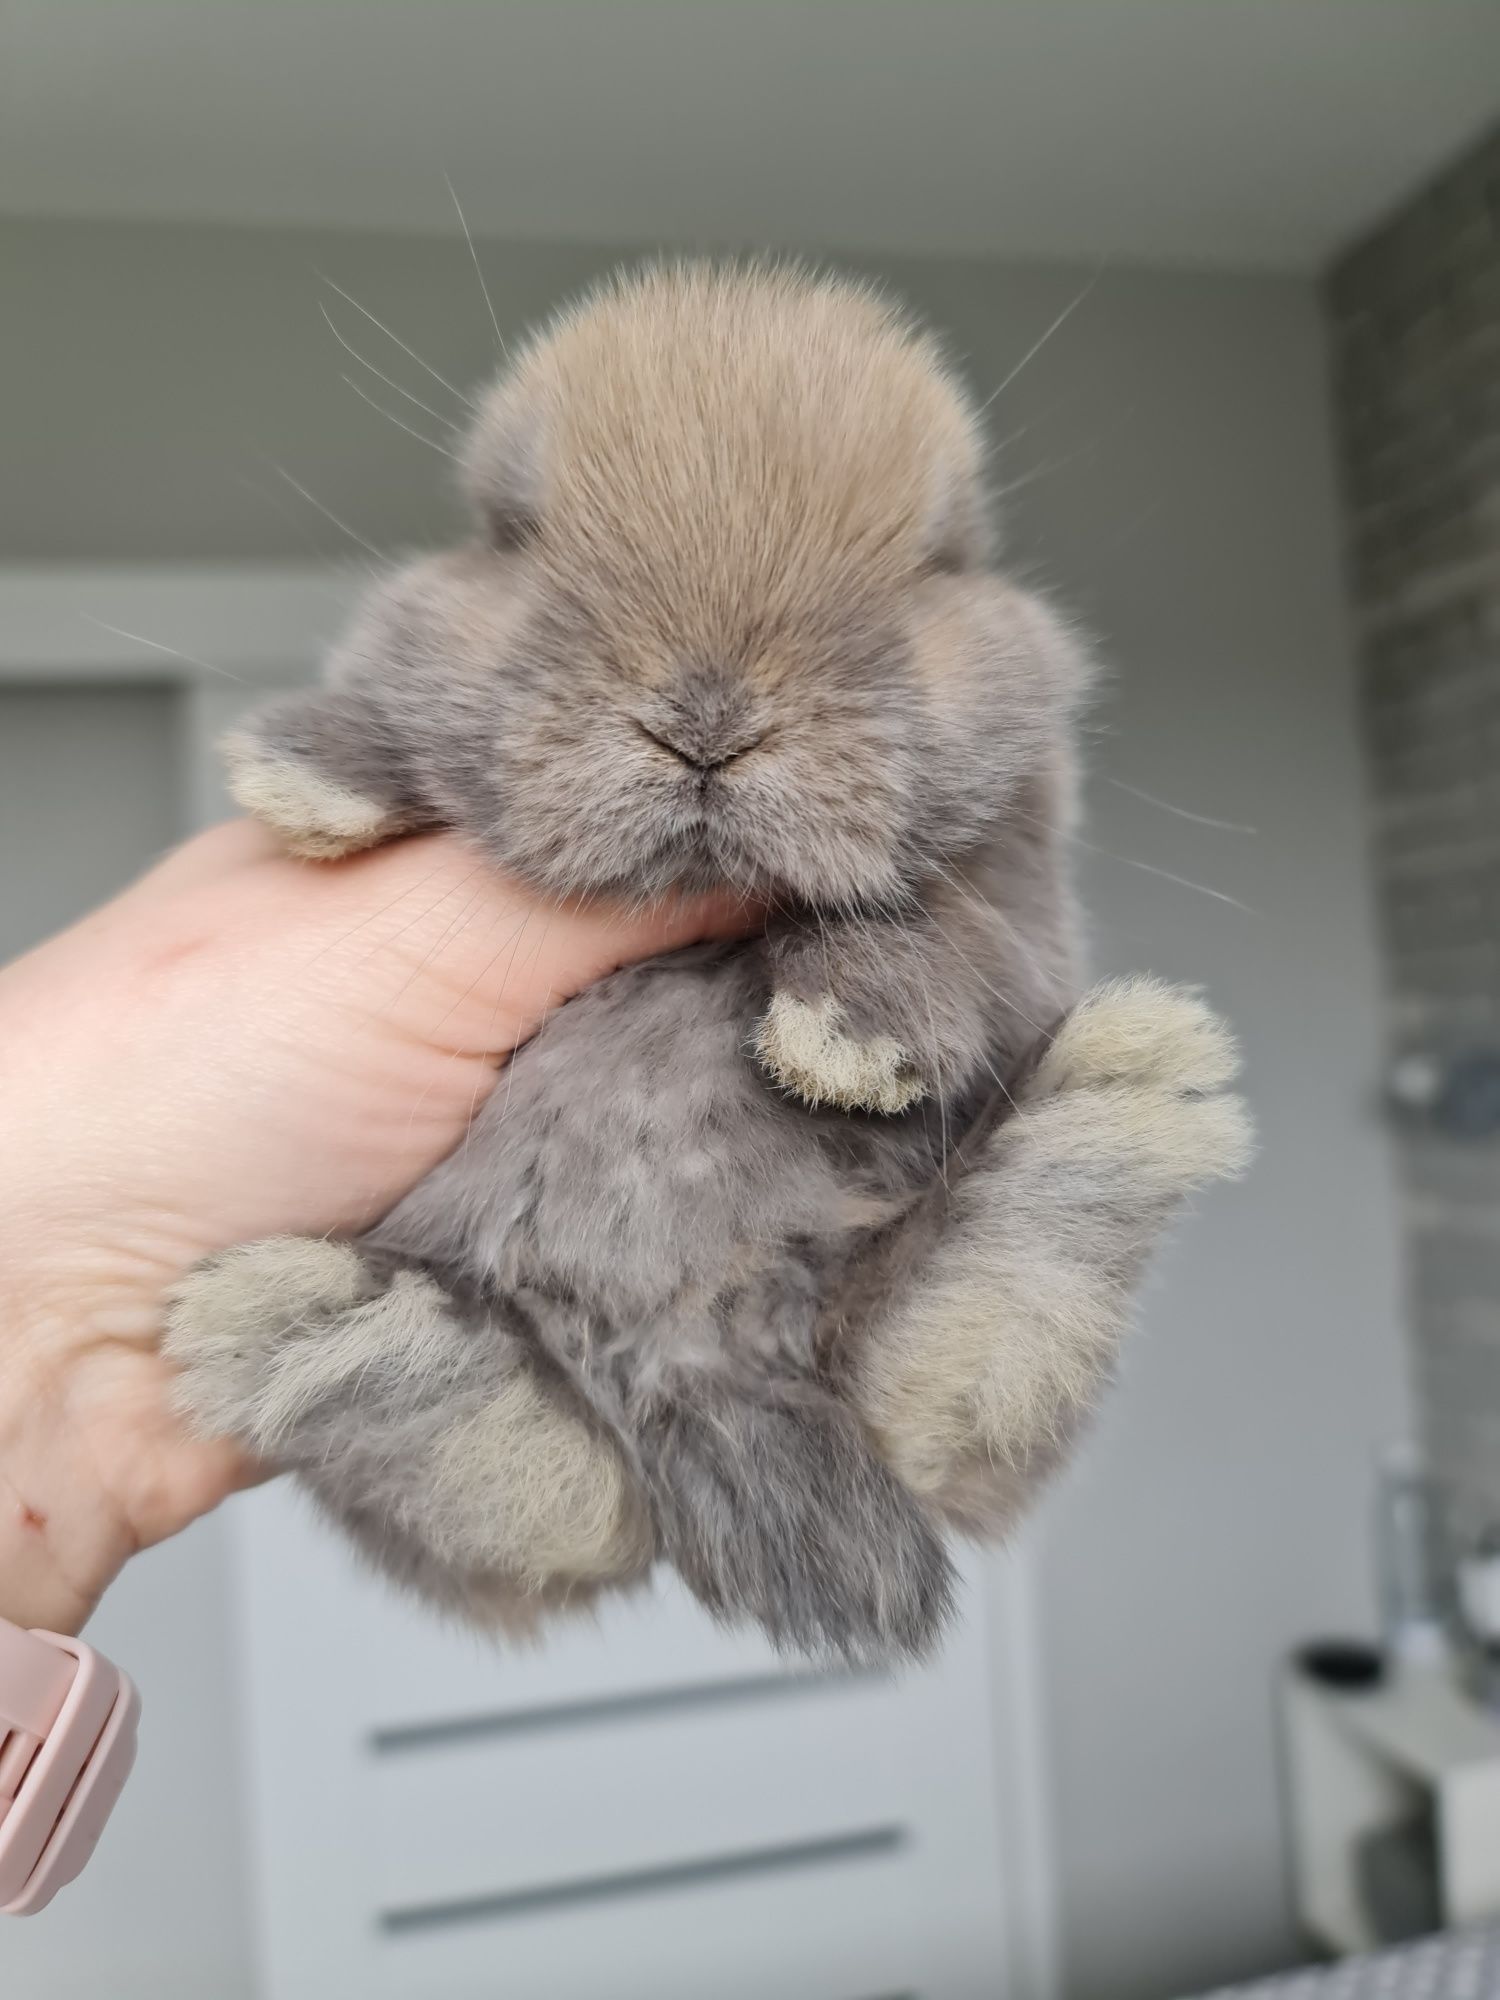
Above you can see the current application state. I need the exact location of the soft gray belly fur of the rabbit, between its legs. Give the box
[366,946,936,1438]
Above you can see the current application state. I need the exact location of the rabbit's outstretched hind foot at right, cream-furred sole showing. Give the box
[856,980,1250,1534]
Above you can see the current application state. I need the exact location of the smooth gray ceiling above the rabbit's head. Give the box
[0,0,1500,270]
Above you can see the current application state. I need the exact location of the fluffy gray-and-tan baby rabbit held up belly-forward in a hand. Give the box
[168,264,1246,1660]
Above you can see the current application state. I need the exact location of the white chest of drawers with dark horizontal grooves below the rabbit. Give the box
[240,1488,1008,2000]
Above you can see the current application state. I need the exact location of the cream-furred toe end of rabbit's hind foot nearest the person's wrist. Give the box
[162,1236,368,1450]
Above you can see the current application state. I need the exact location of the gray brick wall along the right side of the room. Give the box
[1326,130,1500,1522]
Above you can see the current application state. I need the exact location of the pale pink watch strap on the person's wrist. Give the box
[0,1618,140,1916]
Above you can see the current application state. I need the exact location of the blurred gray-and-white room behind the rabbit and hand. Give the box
[0,11,1500,2000]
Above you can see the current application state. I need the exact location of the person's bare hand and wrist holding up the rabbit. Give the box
[0,822,754,1632]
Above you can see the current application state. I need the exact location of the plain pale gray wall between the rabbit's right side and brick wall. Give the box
[1012,280,1408,2000]
